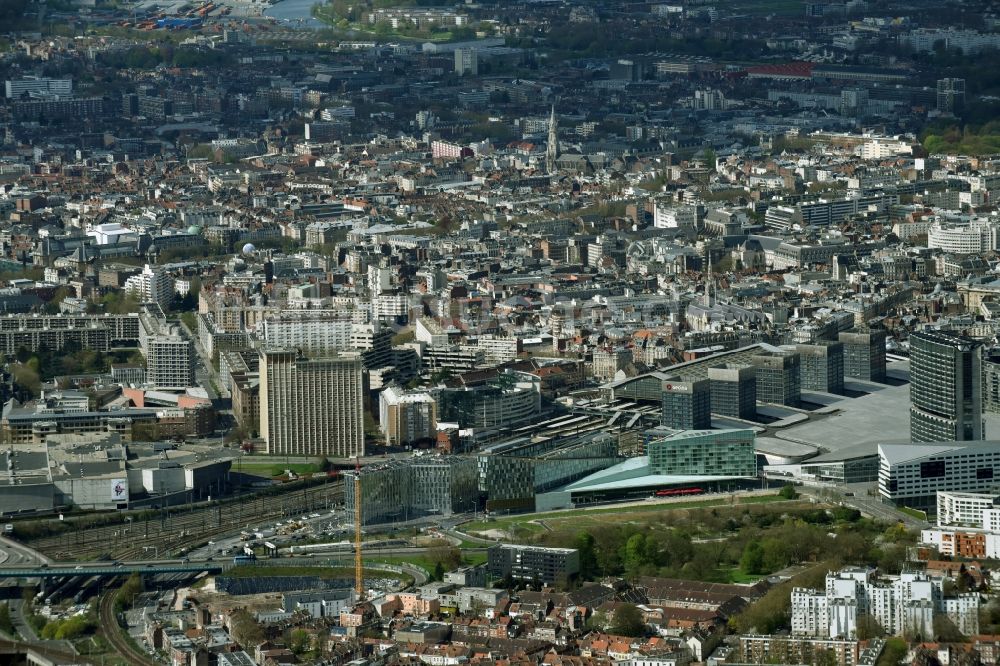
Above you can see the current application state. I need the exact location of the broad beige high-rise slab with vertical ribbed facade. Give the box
[260,349,365,458]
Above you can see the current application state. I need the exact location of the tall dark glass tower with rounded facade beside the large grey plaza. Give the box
[910,331,985,442]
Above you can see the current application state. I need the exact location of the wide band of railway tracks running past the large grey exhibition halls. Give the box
[25,482,343,560]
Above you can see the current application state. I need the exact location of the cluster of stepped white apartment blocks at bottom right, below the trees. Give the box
[792,567,979,639]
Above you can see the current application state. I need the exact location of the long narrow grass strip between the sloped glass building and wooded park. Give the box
[460,495,796,533]
